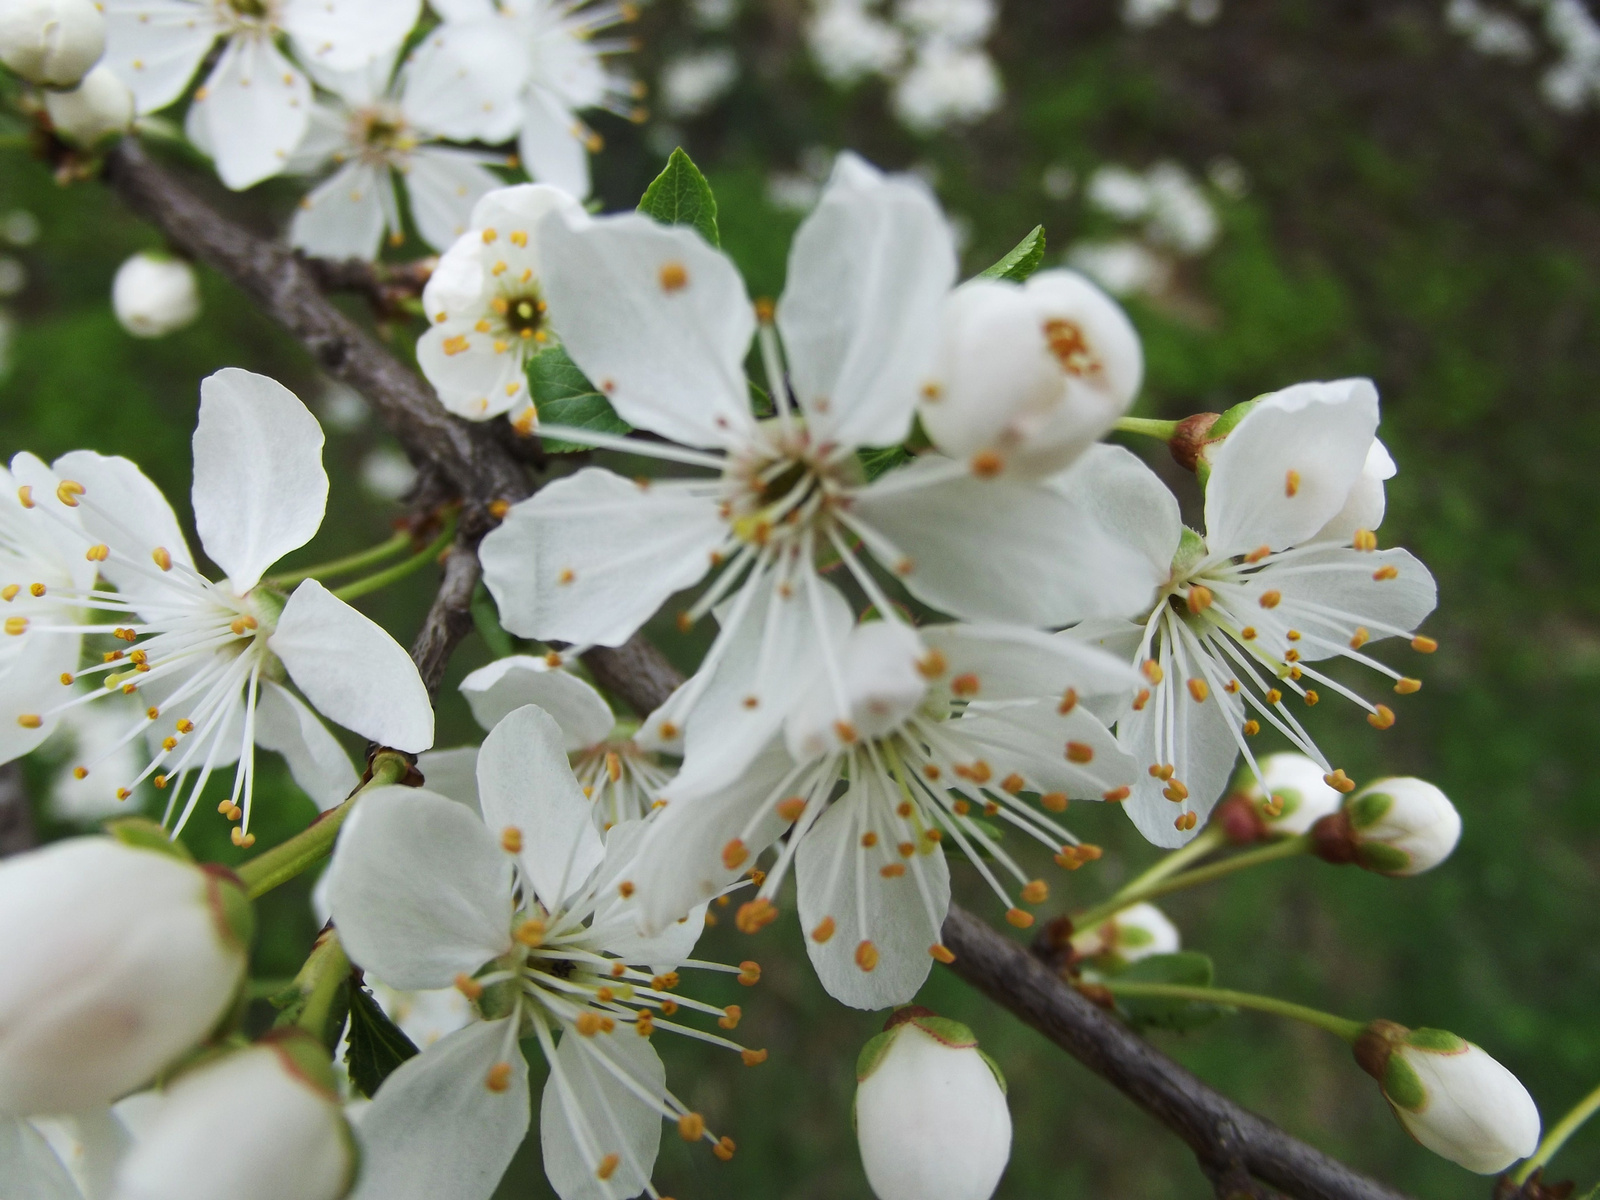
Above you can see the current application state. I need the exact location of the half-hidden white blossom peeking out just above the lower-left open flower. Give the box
[461,654,674,832]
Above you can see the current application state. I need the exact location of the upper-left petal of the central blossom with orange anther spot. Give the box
[539,213,755,446]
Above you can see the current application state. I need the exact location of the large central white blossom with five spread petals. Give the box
[482,155,1165,790]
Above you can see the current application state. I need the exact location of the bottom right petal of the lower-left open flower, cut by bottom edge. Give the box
[539,1026,667,1200]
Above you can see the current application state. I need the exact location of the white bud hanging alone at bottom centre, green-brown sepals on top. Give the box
[856,1008,1011,1200]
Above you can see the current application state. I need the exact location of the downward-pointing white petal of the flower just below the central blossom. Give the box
[795,781,950,1008]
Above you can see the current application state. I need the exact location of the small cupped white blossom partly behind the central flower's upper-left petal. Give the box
[416,184,582,419]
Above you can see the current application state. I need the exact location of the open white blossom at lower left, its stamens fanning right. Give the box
[330,706,766,1200]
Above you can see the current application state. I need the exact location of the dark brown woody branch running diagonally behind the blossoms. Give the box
[87,138,1403,1200]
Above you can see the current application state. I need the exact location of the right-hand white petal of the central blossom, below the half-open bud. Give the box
[854,456,1166,626]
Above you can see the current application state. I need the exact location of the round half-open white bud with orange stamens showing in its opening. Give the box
[920,270,1144,478]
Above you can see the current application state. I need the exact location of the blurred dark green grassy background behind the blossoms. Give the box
[0,0,1600,1200]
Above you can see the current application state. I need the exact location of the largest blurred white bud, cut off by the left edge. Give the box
[0,837,253,1115]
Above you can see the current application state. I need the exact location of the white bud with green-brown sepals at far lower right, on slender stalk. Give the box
[1355,1021,1539,1174]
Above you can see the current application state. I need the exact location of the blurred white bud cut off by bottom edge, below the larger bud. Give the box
[112,1032,357,1200]
